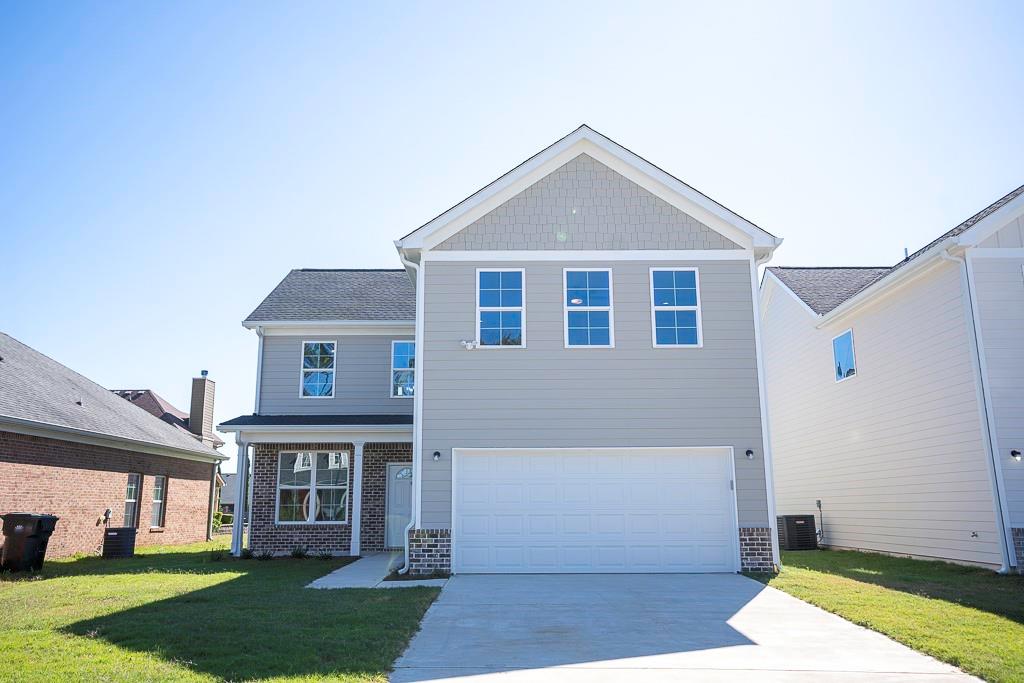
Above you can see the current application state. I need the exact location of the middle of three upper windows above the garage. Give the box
[562,268,615,347]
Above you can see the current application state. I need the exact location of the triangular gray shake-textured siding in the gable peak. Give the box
[435,155,739,251]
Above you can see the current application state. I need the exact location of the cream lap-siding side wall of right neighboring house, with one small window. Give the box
[762,263,1001,566]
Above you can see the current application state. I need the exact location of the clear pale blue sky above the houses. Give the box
[0,2,1024,467]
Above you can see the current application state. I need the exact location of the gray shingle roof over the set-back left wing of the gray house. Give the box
[245,268,416,323]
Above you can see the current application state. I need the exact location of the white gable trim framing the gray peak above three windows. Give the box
[395,124,781,253]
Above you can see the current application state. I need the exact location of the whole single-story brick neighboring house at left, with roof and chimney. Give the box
[0,333,226,557]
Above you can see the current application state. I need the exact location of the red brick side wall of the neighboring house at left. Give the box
[0,432,214,557]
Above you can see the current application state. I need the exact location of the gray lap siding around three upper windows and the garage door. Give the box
[421,255,767,527]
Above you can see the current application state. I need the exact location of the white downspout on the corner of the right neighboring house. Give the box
[939,248,1016,573]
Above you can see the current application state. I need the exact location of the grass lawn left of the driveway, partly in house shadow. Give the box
[0,541,438,682]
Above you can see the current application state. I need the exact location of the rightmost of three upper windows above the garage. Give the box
[650,268,703,347]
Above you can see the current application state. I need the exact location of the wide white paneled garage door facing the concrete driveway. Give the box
[453,449,739,573]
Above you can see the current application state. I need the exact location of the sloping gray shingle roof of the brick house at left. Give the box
[0,332,226,462]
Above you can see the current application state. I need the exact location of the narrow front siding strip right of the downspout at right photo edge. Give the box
[972,255,1024,527]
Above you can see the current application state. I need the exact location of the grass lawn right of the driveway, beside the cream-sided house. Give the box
[755,550,1024,681]
